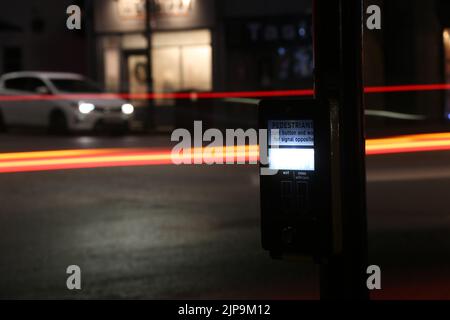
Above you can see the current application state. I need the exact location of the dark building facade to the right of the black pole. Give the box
[364,0,450,123]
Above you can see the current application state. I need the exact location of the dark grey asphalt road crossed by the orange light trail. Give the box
[0,134,450,299]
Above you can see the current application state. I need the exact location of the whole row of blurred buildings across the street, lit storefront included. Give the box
[0,0,450,129]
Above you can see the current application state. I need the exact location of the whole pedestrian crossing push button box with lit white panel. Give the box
[259,100,334,258]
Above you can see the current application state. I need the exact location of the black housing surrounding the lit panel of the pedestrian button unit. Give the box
[259,99,335,259]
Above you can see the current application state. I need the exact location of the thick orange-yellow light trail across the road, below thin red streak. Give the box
[0,132,450,173]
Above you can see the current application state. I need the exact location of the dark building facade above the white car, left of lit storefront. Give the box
[0,0,88,74]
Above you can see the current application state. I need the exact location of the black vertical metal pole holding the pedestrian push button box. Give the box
[314,0,369,300]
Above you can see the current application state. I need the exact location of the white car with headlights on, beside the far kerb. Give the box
[0,72,134,133]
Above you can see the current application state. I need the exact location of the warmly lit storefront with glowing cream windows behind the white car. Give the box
[95,0,215,93]
